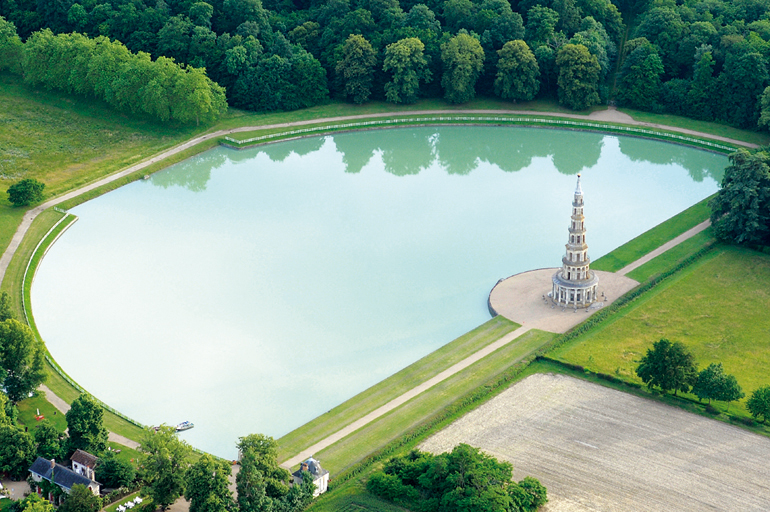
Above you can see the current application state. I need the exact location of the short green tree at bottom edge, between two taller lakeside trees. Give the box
[184,454,235,512]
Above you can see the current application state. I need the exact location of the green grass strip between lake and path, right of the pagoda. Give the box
[591,196,713,274]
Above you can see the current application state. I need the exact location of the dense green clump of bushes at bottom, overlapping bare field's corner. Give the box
[366,444,548,512]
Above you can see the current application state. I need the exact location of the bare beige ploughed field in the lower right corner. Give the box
[421,374,770,512]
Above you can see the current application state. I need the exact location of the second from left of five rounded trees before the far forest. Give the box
[382,37,431,103]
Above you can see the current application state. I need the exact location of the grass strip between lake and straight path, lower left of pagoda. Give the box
[278,316,519,461]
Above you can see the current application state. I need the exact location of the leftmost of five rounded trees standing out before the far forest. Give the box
[335,33,376,104]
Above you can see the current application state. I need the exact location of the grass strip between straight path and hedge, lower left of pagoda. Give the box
[314,330,557,474]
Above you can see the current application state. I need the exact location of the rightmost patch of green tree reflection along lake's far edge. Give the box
[619,137,727,183]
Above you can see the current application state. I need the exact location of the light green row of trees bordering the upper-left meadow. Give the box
[0,18,227,123]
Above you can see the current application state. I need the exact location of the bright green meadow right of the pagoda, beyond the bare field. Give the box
[548,246,770,415]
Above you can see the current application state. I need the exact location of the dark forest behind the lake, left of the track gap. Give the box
[0,0,624,110]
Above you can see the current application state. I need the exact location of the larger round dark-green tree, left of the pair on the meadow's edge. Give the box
[636,339,698,396]
